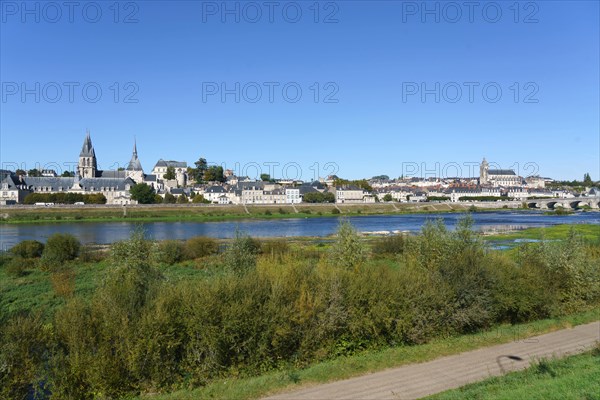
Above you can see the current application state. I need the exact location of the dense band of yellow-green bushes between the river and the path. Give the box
[0,219,600,399]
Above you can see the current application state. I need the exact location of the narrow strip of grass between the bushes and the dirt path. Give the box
[140,308,600,400]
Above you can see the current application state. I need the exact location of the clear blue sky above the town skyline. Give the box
[0,0,600,179]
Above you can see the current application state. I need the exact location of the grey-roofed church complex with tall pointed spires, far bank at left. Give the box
[0,131,159,205]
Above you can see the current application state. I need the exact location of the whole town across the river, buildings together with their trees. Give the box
[0,132,600,208]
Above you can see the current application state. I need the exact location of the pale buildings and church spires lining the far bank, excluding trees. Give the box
[0,132,592,205]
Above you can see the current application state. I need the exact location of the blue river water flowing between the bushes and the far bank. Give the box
[0,211,600,249]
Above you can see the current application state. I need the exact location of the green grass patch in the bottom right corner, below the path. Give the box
[428,348,600,400]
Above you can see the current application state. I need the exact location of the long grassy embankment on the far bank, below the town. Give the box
[0,202,540,224]
